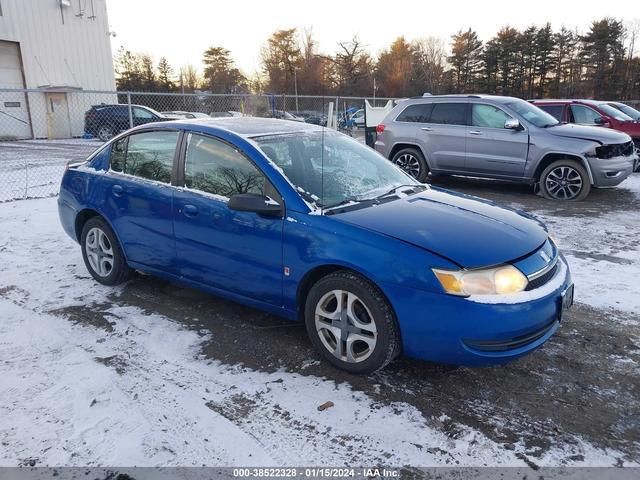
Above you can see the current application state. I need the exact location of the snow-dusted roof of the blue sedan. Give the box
[145,117,324,138]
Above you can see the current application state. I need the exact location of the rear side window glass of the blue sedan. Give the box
[110,131,178,183]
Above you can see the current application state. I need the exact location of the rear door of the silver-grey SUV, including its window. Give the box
[416,100,469,171]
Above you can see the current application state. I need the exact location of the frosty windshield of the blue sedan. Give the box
[254,131,422,208]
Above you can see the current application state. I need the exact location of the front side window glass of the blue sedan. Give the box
[184,134,266,198]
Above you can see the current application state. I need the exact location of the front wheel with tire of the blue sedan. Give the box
[305,270,400,374]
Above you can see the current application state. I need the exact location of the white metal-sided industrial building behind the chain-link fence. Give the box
[0,0,117,139]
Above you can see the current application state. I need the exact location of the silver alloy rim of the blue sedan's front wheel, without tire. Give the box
[315,290,378,363]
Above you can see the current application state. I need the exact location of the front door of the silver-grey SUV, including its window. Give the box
[465,102,529,176]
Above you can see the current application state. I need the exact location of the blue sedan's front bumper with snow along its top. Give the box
[383,259,572,366]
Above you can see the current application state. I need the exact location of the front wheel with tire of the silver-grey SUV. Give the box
[540,158,591,201]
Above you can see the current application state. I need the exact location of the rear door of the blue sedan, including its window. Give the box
[102,130,180,273]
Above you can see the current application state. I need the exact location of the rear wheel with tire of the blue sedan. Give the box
[80,217,133,285]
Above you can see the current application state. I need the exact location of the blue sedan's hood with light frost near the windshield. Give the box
[334,188,548,268]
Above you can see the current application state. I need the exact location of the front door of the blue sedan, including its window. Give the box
[173,133,283,306]
